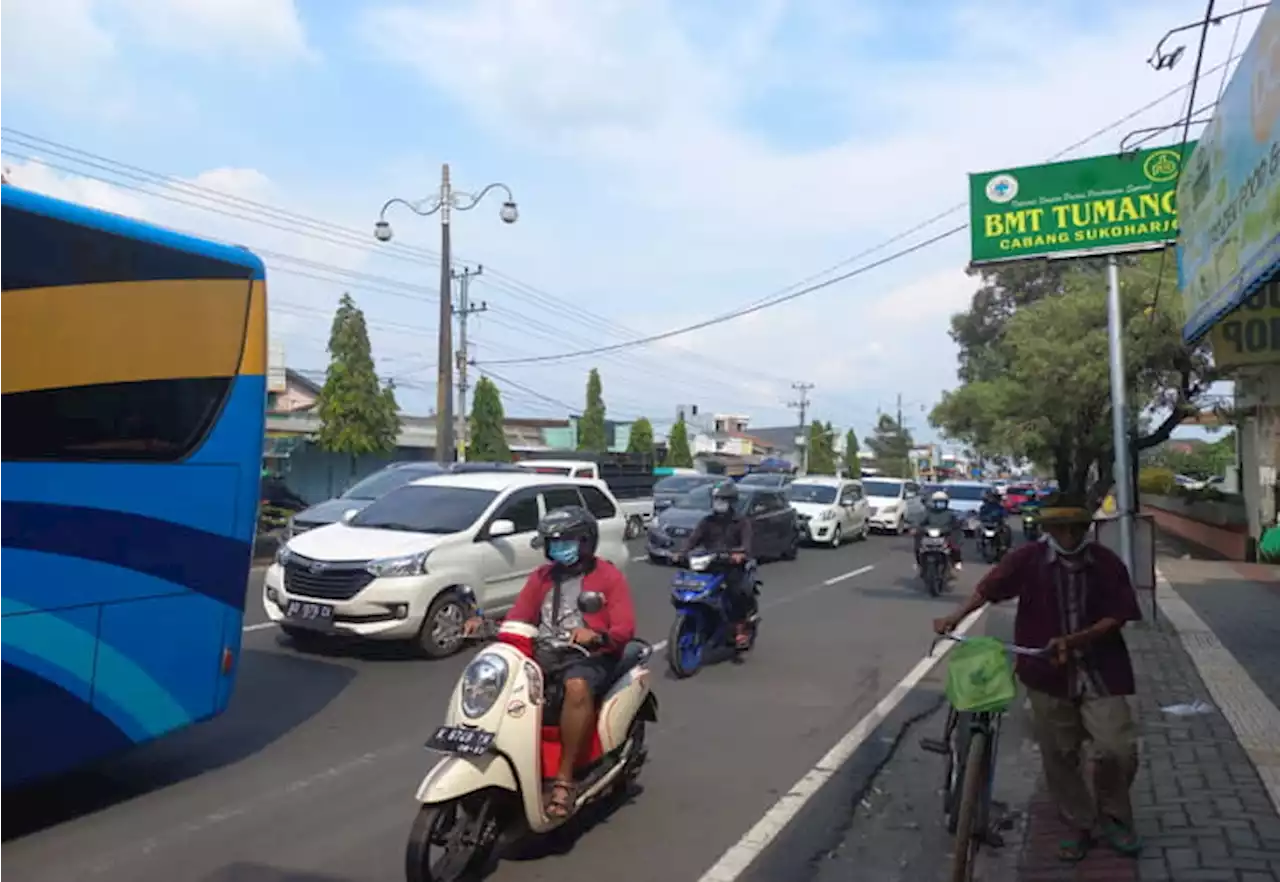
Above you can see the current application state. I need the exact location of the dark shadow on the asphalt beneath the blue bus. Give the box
[0,649,356,839]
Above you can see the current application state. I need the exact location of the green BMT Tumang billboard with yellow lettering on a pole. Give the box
[969,143,1194,264]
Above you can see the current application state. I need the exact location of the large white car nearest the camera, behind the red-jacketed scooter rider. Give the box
[262,471,628,658]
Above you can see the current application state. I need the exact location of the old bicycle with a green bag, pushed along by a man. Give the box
[920,634,1048,882]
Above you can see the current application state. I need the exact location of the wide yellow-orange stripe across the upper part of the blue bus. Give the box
[0,279,252,394]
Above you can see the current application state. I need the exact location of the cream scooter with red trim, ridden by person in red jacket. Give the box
[404,583,658,882]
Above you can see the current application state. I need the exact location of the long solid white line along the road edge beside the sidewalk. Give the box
[698,609,984,882]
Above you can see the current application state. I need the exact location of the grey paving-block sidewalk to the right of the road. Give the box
[1018,561,1280,882]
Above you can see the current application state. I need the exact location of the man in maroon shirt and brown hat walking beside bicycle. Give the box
[933,497,1142,863]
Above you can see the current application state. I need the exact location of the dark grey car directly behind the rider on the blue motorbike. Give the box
[645,485,800,563]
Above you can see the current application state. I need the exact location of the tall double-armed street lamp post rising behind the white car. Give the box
[374,163,520,463]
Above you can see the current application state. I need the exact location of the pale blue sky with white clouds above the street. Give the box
[0,0,1253,435]
